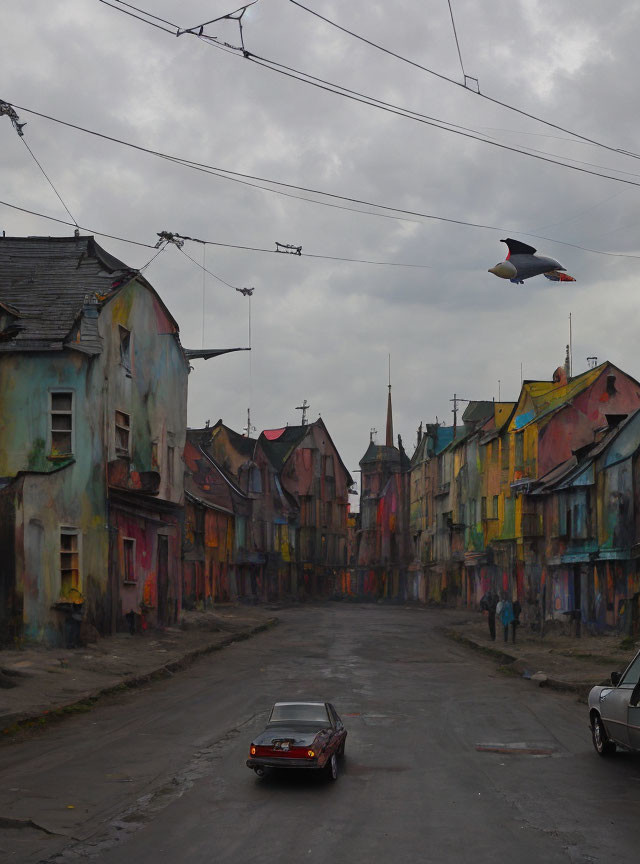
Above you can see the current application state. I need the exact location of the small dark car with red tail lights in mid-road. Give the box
[247,702,347,780]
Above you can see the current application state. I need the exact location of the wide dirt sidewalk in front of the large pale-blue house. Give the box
[0,605,278,736]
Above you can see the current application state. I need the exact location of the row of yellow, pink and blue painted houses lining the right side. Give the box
[404,363,640,630]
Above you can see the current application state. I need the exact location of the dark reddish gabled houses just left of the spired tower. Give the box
[199,419,352,600]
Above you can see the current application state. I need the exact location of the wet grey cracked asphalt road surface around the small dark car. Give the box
[0,603,640,864]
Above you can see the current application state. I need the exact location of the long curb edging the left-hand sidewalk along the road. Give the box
[0,618,280,740]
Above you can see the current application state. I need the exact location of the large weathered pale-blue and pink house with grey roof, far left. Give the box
[0,236,188,644]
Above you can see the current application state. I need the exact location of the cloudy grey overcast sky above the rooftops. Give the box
[0,0,640,496]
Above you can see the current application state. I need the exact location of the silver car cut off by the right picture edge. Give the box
[589,651,640,756]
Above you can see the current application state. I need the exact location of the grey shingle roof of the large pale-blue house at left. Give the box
[0,237,135,353]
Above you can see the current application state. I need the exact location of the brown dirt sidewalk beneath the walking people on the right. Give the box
[439,609,640,699]
